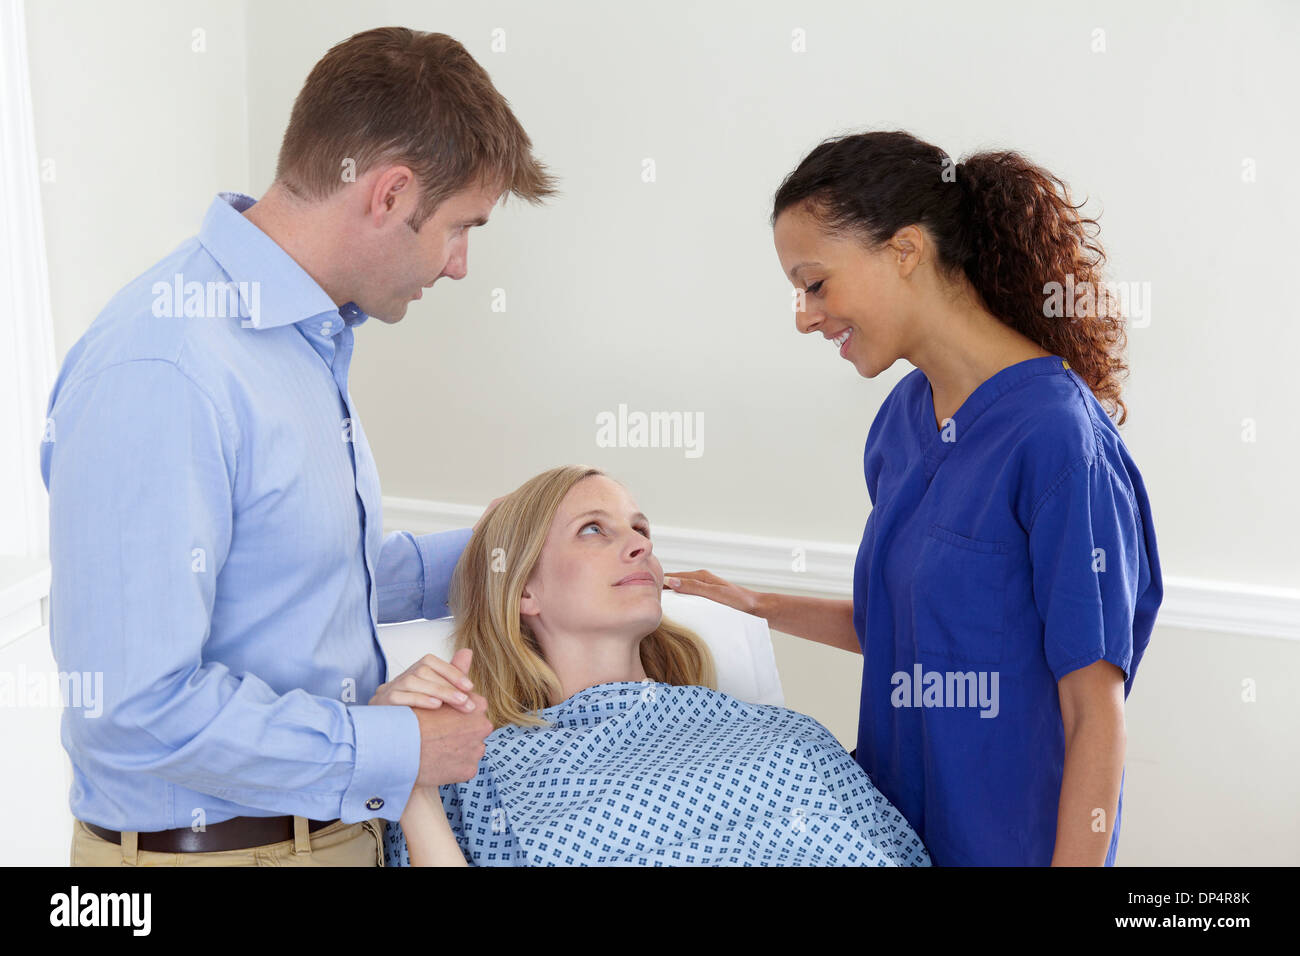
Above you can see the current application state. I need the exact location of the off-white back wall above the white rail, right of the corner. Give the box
[248,0,1300,587]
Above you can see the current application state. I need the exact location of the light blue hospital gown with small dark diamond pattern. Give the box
[385,680,930,866]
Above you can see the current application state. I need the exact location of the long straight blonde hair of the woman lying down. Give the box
[450,464,716,727]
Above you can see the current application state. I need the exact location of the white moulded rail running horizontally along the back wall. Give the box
[384,497,1300,640]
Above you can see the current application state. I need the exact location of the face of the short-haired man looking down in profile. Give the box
[355,179,502,324]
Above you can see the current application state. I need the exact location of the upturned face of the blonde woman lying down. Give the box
[520,475,663,657]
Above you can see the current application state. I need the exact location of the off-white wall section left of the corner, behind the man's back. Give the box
[27,0,248,362]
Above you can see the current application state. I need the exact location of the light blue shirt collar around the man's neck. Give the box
[199,193,369,336]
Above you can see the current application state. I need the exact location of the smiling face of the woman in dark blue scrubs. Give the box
[772,204,914,378]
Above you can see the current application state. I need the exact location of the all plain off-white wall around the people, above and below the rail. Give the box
[29,0,1300,864]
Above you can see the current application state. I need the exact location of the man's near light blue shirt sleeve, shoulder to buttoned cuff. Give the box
[42,359,420,822]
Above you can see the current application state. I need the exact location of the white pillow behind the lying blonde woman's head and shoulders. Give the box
[380,591,785,706]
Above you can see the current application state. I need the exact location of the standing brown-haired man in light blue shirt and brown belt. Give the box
[40,27,550,864]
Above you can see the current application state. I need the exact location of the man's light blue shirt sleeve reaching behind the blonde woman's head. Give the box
[374,528,473,624]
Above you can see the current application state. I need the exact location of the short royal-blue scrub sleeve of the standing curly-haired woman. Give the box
[1030,455,1144,693]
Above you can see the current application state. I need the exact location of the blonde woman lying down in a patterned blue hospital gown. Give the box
[377,466,930,866]
